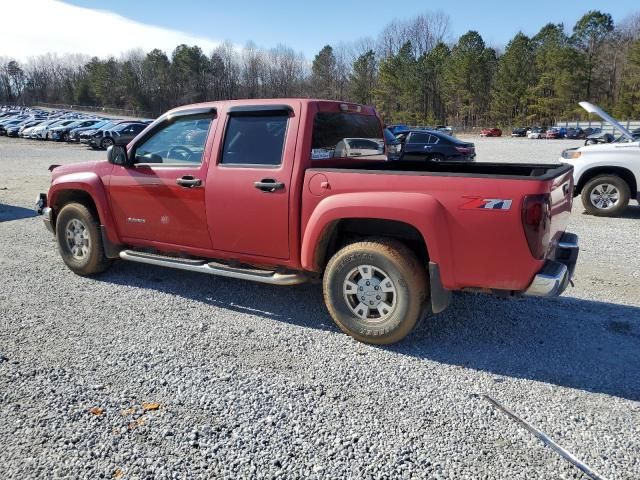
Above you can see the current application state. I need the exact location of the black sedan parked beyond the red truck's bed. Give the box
[398,130,476,162]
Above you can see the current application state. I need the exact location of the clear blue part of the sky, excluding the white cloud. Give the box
[65,0,640,57]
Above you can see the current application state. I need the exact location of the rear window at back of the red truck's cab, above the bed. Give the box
[311,112,386,161]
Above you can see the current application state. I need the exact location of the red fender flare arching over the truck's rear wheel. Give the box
[301,192,455,285]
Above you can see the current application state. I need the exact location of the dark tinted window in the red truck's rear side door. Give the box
[220,115,288,165]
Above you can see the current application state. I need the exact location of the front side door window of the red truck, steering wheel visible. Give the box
[132,116,213,164]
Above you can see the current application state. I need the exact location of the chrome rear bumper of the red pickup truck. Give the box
[524,232,580,297]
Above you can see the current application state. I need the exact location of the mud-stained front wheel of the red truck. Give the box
[56,203,111,276]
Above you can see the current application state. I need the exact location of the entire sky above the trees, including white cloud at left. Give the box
[0,0,640,60]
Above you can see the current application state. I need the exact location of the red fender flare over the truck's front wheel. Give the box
[47,172,120,243]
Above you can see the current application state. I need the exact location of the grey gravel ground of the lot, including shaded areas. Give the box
[0,137,640,479]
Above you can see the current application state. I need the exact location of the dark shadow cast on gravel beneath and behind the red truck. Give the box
[99,262,640,400]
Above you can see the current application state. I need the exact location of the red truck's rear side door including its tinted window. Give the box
[206,103,299,259]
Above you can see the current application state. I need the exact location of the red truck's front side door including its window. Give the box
[109,115,215,249]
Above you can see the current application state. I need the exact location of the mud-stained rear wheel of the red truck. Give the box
[323,239,428,345]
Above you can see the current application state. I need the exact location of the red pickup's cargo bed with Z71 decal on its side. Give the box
[303,161,573,291]
